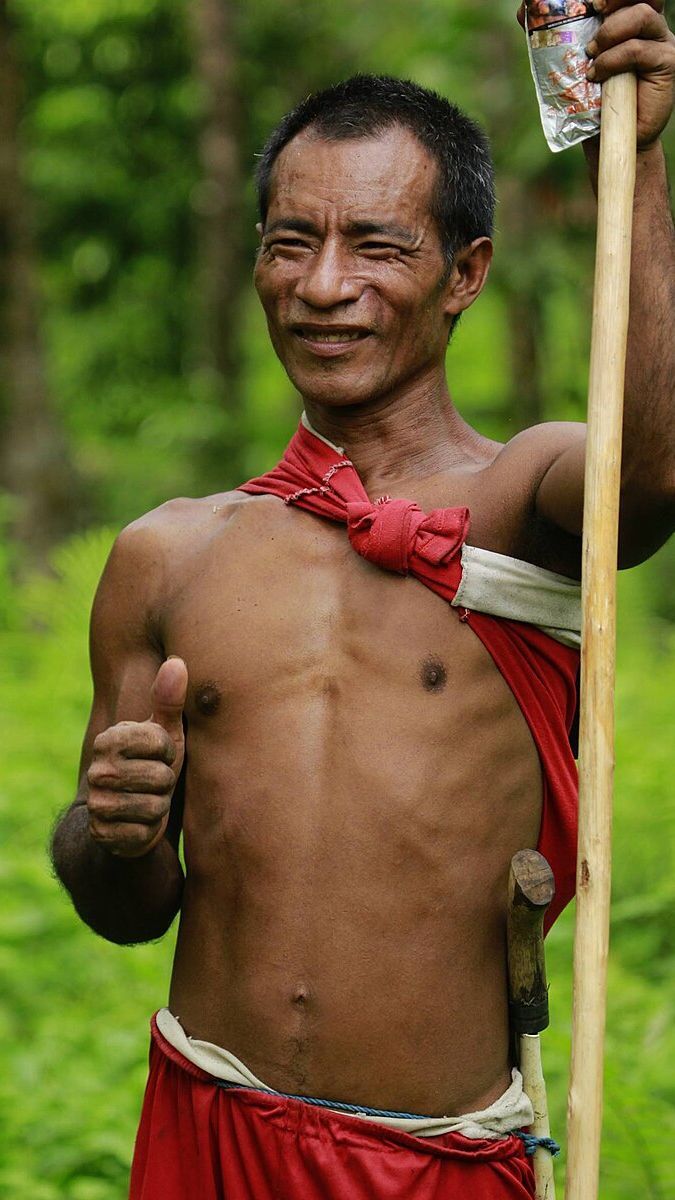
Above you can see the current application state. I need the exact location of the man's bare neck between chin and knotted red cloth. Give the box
[299,379,477,494]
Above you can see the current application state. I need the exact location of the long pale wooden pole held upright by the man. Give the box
[566,74,637,1200]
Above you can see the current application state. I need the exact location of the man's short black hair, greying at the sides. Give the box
[256,74,495,265]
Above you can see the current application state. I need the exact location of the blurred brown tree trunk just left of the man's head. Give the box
[193,0,249,488]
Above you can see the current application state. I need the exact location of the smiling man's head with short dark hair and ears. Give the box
[256,77,494,407]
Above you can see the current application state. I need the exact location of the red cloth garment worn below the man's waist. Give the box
[130,1021,534,1200]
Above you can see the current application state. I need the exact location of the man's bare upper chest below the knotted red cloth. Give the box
[162,498,530,732]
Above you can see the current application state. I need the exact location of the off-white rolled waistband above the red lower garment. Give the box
[156,1008,534,1139]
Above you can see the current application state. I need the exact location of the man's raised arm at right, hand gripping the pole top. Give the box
[537,0,675,566]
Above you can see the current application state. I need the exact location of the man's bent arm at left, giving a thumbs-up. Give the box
[52,524,187,944]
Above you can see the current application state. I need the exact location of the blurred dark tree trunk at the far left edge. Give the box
[0,0,82,559]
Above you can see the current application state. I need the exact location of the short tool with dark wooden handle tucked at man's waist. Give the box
[507,850,555,1200]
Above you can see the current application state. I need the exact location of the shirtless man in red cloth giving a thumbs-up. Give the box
[54,0,675,1200]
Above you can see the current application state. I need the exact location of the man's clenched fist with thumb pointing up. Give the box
[86,658,187,858]
